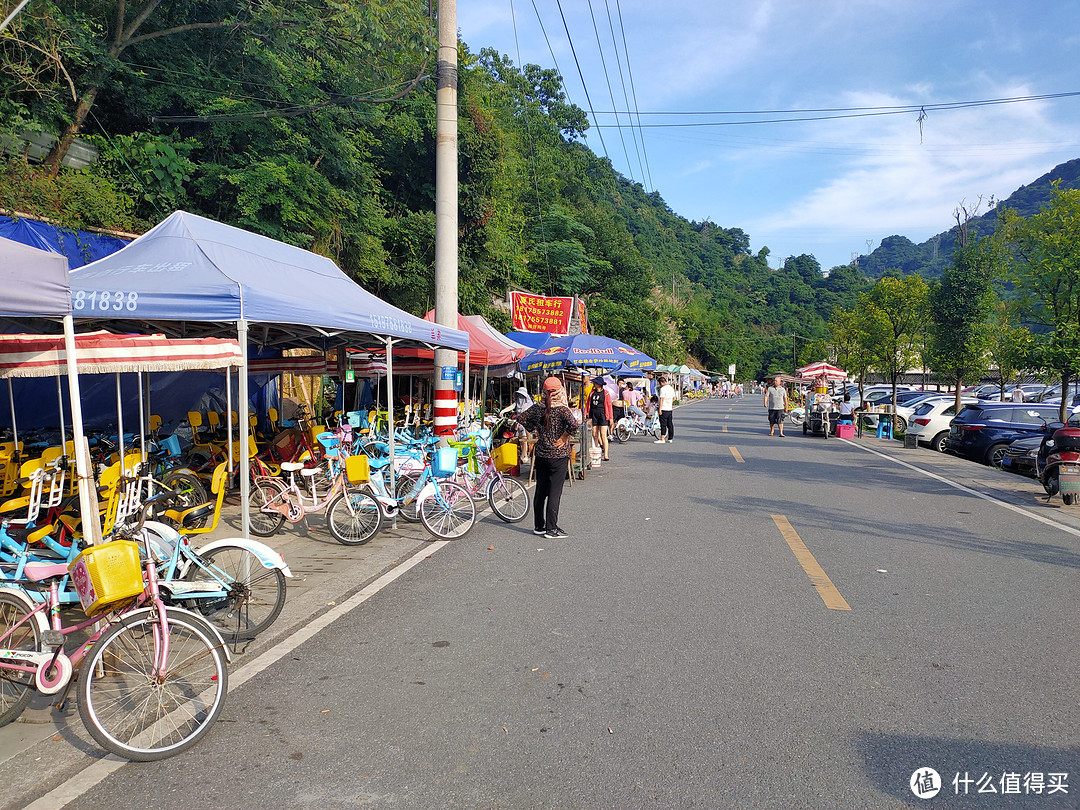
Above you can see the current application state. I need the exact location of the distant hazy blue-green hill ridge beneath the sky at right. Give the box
[859,158,1080,279]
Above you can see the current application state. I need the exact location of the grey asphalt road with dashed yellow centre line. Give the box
[8,396,1080,810]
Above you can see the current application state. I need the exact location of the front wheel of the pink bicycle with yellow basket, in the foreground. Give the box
[79,611,229,762]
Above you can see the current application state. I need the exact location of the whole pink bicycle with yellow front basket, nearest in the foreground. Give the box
[0,495,229,761]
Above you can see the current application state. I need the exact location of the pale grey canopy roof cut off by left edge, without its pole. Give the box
[0,238,71,318]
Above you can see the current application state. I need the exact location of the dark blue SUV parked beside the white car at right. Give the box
[946,402,1057,467]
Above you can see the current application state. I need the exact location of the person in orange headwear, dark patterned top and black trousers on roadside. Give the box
[514,377,581,540]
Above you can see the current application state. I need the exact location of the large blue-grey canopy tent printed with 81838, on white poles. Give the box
[65,211,469,535]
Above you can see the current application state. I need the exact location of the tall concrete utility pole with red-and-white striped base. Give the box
[429,0,460,436]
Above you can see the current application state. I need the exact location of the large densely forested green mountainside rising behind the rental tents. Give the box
[0,0,866,376]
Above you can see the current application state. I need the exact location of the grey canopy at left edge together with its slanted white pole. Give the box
[0,238,102,543]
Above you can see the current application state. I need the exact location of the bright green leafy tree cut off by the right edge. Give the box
[998,185,1080,421]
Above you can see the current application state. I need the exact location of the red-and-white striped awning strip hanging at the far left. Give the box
[0,332,243,378]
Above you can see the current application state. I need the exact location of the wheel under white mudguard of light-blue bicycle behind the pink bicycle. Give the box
[184,545,285,642]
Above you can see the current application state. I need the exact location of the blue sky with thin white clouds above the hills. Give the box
[457,0,1080,271]
